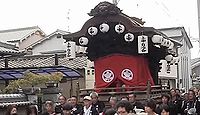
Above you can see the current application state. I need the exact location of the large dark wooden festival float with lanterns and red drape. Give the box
[63,2,174,97]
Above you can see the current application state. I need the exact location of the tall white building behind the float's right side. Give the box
[159,27,193,90]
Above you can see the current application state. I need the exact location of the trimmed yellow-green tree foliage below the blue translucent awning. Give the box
[3,72,63,93]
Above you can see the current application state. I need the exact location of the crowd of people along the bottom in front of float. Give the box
[6,88,200,115]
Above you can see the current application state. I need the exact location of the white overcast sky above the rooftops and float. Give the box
[0,0,199,58]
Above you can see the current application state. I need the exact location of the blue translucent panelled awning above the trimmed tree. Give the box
[0,66,82,80]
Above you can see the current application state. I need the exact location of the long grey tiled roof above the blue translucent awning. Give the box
[0,55,87,69]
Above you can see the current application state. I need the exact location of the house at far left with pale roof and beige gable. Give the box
[0,26,45,51]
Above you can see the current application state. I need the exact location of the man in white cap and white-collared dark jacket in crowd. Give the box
[80,96,99,115]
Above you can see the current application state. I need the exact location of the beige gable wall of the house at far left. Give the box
[19,32,43,50]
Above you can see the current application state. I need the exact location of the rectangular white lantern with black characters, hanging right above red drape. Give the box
[138,35,148,54]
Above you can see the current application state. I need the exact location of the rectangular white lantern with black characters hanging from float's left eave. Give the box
[66,41,76,59]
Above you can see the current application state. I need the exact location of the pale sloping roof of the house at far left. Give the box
[0,26,44,42]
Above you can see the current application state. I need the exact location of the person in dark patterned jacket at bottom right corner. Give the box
[181,90,200,115]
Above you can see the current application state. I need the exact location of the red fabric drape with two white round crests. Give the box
[94,54,154,91]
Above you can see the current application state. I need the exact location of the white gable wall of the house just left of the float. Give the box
[32,35,66,55]
